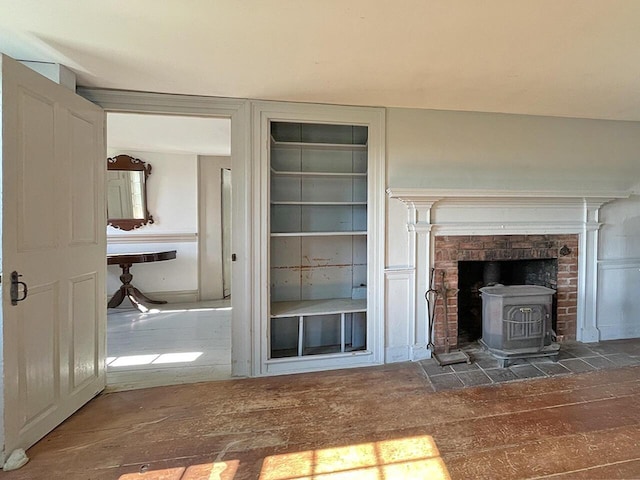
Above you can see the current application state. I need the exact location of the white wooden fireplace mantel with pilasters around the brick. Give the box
[386,188,630,360]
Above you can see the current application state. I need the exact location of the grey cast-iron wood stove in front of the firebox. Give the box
[480,285,560,368]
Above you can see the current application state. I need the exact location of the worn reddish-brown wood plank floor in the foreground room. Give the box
[2,363,640,480]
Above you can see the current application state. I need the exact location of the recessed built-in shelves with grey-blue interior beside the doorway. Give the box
[268,121,368,362]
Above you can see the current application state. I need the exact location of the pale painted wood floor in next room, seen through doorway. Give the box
[107,299,231,391]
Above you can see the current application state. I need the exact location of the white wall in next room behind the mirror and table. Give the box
[107,149,198,301]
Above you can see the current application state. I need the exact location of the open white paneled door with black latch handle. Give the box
[0,56,106,456]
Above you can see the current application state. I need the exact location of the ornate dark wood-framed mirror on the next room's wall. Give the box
[107,155,153,230]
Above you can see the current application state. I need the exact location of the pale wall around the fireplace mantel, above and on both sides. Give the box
[385,108,640,361]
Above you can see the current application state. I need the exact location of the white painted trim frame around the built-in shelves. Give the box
[251,102,385,375]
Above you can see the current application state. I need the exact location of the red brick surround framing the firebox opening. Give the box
[434,235,578,351]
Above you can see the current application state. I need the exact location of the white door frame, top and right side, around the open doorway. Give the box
[78,88,251,377]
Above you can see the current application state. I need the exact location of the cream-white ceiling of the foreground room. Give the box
[0,0,640,121]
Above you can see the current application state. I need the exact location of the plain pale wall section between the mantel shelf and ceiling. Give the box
[387,108,640,191]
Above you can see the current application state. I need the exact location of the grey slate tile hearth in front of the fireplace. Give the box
[419,339,640,391]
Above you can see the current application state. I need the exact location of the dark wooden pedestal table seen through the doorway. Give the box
[107,250,176,312]
